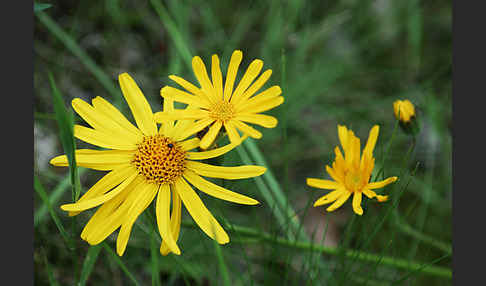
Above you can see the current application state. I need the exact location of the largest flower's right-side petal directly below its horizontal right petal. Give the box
[184,170,259,205]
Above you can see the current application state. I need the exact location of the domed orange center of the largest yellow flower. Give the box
[132,134,186,184]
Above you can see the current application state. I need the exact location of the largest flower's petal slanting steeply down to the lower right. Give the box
[175,178,229,244]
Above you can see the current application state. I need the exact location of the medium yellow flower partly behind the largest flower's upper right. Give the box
[155,50,284,149]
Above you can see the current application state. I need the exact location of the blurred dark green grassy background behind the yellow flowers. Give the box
[34,0,452,285]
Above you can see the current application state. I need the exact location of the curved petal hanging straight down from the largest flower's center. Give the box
[155,184,181,255]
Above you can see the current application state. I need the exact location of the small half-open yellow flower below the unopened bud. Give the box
[307,125,398,215]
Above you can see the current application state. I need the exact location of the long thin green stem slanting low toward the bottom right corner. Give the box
[181,221,452,279]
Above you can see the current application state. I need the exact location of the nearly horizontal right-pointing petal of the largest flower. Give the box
[186,161,267,180]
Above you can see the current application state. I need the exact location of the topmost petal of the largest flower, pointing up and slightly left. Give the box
[118,73,157,136]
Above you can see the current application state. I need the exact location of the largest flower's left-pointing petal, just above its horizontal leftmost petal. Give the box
[74,124,137,150]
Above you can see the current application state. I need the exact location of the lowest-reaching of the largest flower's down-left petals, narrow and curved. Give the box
[116,184,158,256]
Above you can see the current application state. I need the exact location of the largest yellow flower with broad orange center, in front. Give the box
[51,73,266,256]
